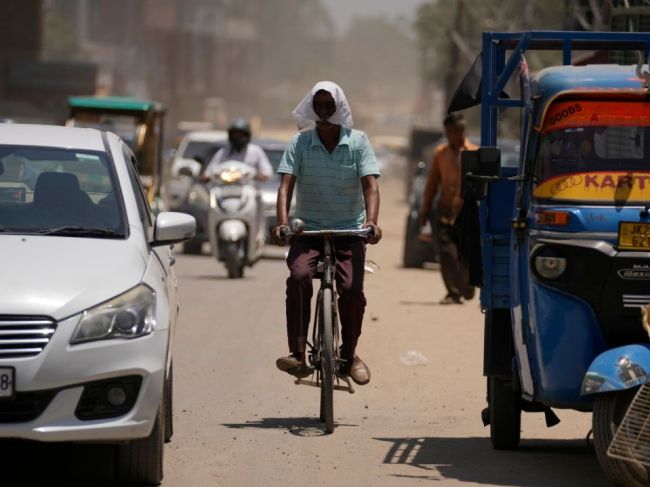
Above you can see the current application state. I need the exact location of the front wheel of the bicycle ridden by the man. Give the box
[318,289,336,433]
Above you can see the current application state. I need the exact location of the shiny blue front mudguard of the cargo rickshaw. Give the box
[581,344,650,396]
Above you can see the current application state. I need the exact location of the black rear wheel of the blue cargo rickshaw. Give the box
[488,377,521,450]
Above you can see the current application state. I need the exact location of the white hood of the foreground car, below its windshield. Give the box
[0,235,146,320]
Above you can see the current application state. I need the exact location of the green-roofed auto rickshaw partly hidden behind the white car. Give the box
[66,96,166,213]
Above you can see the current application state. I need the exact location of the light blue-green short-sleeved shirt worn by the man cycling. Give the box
[278,127,379,230]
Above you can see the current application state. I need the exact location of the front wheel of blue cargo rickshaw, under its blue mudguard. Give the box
[592,388,650,487]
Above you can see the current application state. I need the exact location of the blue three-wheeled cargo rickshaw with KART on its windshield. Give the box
[452,31,650,487]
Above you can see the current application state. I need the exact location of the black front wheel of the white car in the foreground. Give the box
[115,400,165,485]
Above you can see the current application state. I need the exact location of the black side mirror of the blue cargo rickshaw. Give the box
[460,147,501,199]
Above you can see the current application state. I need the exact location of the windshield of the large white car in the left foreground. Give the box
[0,146,126,238]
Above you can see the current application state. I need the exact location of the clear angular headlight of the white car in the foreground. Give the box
[70,284,155,344]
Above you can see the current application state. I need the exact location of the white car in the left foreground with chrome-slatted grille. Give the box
[0,124,195,484]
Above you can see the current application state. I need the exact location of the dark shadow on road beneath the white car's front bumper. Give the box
[0,440,125,487]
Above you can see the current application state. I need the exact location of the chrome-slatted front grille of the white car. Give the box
[0,315,56,360]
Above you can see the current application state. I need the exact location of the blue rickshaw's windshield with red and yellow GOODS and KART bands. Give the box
[534,101,650,204]
